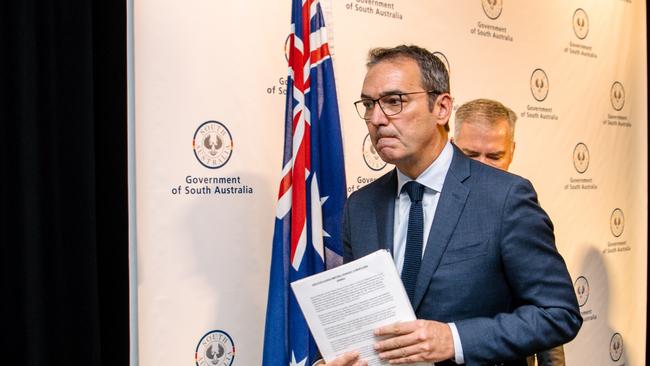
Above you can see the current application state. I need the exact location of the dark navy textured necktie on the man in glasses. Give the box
[402,181,424,304]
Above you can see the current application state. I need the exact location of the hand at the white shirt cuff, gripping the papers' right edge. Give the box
[375,319,454,364]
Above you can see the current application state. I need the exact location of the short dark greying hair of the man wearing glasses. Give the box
[366,45,449,131]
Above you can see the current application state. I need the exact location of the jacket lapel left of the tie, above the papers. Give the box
[375,169,397,255]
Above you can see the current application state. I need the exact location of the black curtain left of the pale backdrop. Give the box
[0,0,129,366]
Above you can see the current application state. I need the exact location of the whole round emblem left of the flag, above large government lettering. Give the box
[192,121,233,169]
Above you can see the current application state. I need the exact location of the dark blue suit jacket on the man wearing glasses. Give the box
[343,144,582,365]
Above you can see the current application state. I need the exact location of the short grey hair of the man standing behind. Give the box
[454,99,517,141]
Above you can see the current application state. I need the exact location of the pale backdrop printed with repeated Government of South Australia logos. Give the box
[131,0,647,366]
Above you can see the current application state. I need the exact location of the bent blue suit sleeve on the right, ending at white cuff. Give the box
[455,179,582,364]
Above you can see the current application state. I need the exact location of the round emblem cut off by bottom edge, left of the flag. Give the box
[194,330,235,366]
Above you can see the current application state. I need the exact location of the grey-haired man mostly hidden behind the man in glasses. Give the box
[452,99,565,366]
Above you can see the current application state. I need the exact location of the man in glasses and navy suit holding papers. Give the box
[318,46,582,366]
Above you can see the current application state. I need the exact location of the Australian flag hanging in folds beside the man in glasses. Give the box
[262,0,346,366]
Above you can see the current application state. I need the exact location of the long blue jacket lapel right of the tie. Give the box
[413,146,470,310]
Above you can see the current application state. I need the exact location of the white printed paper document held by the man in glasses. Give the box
[291,250,433,366]
